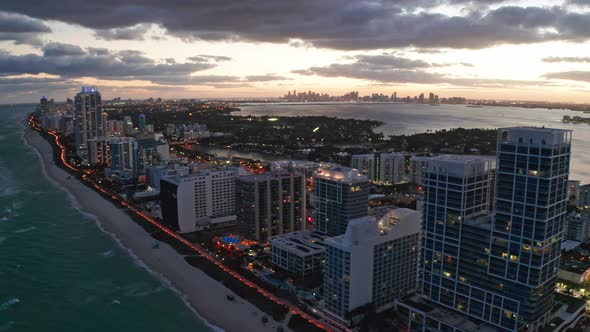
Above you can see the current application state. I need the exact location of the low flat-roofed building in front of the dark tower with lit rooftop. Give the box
[268,230,326,279]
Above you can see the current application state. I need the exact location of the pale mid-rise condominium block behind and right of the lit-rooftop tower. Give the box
[351,152,406,183]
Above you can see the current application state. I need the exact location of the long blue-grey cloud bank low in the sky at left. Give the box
[0,43,215,79]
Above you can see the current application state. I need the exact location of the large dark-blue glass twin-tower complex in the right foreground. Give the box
[398,127,571,331]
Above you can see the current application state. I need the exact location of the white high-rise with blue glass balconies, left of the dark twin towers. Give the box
[324,209,420,321]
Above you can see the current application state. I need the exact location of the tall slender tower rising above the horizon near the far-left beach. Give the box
[74,87,103,158]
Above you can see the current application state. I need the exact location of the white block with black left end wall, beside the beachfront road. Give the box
[160,167,242,233]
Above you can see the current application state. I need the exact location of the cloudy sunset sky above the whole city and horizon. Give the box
[0,0,590,104]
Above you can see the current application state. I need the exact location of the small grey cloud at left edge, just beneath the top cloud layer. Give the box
[0,11,51,45]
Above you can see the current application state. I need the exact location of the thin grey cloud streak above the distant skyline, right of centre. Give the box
[293,56,550,87]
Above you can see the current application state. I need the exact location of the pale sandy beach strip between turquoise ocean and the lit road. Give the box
[25,127,288,332]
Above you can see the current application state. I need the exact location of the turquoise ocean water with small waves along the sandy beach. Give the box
[0,105,213,332]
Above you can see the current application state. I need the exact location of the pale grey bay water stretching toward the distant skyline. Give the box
[239,104,590,183]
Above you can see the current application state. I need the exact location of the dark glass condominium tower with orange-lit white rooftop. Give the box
[313,165,369,236]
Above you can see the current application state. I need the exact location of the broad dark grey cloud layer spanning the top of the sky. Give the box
[0,0,590,50]
